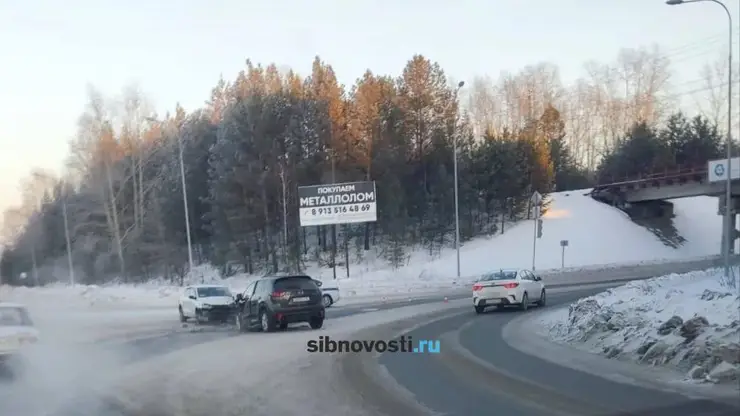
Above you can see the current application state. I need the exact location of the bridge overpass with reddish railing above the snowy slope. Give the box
[591,158,740,252]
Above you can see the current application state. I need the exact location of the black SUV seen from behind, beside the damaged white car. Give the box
[231,275,324,332]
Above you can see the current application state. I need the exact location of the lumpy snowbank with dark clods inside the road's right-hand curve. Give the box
[538,269,740,382]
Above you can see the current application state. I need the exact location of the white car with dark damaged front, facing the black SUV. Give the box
[177,285,235,323]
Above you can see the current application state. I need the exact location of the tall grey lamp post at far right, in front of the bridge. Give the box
[666,0,735,286]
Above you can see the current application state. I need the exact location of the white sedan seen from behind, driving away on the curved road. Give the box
[473,269,547,313]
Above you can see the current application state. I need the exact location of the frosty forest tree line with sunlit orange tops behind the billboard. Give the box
[0,49,736,284]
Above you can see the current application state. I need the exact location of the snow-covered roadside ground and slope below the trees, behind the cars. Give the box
[0,190,721,309]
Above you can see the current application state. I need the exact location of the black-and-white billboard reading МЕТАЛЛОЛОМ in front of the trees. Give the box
[298,182,378,227]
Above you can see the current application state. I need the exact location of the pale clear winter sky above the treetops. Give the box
[0,0,740,221]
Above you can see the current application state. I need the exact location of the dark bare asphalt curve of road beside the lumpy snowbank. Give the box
[379,289,740,416]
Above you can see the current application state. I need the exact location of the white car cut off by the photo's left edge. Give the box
[0,302,39,367]
